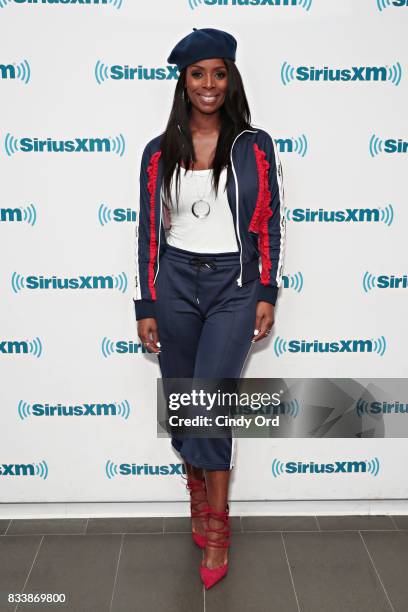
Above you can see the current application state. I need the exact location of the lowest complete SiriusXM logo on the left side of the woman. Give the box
[17,400,130,421]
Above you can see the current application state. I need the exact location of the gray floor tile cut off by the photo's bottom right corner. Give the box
[362,531,408,612]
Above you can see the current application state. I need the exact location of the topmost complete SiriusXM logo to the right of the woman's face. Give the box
[281,62,402,86]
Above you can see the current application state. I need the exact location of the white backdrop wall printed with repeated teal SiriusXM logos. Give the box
[0,0,408,502]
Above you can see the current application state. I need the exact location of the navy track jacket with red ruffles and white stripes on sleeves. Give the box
[133,129,286,320]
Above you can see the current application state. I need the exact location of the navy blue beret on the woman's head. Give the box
[167,28,237,70]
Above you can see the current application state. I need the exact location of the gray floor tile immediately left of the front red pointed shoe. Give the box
[112,533,203,612]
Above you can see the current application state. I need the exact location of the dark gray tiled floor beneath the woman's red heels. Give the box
[0,516,408,612]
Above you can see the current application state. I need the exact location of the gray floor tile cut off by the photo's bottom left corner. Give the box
[0,535,41,612]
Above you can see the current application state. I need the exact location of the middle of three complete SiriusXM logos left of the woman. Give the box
[11,272,128,293]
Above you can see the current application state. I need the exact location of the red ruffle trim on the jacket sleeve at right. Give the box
[249,144,272,285]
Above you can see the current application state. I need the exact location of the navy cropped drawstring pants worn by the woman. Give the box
[155,245,259,470]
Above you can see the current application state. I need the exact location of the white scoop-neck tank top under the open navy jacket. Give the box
[167,168,238,253]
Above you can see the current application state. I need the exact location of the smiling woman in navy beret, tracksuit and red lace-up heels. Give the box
[134,28,285,588]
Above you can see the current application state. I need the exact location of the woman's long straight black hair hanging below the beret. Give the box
[160,59,252,206]
